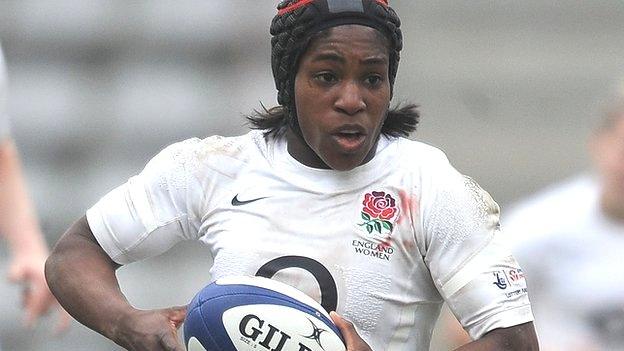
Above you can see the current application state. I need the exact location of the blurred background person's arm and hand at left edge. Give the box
[0,42,70,342]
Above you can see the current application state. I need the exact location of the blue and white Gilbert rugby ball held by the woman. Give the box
[184,276,346,351]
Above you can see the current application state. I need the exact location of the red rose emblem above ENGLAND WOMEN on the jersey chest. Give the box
[359,191,398,234]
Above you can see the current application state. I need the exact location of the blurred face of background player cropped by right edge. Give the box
[592,113,624,198]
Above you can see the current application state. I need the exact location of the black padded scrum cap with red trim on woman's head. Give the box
[271,0,403,114]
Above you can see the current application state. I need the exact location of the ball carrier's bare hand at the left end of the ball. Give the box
[111,306,186,351]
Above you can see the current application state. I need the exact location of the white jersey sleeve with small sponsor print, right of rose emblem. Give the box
[421,157,533,339]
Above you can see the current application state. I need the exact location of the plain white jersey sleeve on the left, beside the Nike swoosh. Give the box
[87,139,203,264]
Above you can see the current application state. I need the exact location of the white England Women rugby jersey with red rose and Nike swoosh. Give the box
[87,131,533,350]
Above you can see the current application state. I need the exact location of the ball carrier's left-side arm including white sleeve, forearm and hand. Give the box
[46,139,203,351]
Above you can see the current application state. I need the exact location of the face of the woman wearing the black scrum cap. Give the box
[288,25,391,170]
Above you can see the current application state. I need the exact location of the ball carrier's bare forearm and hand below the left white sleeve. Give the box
[45,217,186,351]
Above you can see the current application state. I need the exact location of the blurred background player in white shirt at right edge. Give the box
[504,95,624,350]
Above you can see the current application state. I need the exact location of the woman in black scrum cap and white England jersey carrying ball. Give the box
[46,0,537,350]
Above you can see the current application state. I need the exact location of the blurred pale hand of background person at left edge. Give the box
[8,253,71,334]
